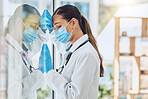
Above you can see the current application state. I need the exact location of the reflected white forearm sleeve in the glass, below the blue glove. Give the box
[22,70,45,99]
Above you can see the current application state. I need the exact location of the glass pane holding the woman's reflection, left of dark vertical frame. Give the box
[0,0,53,99]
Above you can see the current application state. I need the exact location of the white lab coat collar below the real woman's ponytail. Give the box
[69,34,88,52]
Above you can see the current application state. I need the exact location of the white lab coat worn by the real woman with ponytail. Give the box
[46,35,100,99]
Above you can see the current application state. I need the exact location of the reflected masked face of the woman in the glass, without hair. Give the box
[23,15,39,43]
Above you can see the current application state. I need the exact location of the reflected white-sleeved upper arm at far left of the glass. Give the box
[6,44,22,99]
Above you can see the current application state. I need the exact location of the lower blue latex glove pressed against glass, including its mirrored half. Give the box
[38,44,53,73]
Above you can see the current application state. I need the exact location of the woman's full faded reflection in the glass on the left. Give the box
[6,4,45,99]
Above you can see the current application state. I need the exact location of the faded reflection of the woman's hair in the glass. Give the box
[5,4,41,34]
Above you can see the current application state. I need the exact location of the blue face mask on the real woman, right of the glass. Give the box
[55,21,72,43]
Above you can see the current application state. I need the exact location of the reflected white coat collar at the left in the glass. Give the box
[6,34,23,52]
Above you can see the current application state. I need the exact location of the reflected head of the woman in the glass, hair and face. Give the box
[6,4,40,44]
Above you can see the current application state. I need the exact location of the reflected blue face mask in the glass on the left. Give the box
[23,24,38,43]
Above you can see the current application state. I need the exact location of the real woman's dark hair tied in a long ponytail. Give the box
[53,5,104,77]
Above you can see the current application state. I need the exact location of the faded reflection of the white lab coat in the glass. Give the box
[6,31,45,99]
